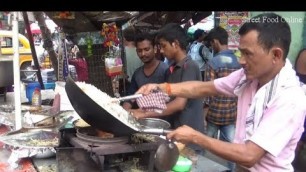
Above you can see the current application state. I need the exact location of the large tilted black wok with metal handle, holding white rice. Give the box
[65,76,170,136]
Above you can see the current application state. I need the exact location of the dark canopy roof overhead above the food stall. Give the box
[45,11,212,33]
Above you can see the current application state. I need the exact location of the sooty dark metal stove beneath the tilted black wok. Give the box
[56,128,165,172]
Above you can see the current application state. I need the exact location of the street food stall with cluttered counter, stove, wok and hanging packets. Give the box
[0,11,227,172]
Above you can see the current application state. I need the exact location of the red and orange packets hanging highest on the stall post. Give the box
[101,23,119,47]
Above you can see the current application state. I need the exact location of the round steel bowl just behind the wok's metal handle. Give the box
[138,118,171,129]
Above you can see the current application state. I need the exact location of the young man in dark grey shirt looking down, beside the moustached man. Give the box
[132,23,204,154]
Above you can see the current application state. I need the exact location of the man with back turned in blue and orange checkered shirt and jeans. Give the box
[206,27,241,170]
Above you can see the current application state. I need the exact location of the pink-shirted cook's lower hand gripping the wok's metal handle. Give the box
[167,125,198,144]
